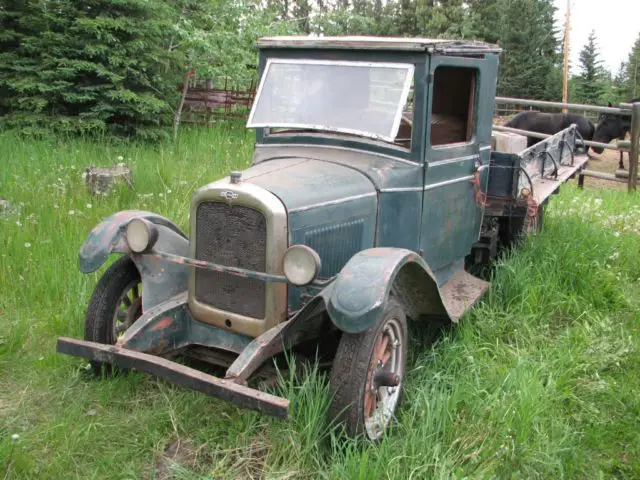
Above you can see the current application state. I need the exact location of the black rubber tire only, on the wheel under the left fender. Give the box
[84,256,141,375]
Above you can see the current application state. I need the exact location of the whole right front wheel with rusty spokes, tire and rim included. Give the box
[331,298,407,440]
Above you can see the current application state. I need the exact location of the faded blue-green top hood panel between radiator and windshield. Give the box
[242,157,376,212]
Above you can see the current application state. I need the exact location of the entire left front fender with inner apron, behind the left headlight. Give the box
[79,210,189,311]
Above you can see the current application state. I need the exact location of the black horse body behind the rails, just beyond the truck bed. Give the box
[504,110,595,150]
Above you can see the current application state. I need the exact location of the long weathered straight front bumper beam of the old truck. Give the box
[56,337,289,419]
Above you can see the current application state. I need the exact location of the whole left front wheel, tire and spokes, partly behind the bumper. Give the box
[84,257,142,374]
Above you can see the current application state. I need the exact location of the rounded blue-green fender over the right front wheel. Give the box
[323,248,449,333]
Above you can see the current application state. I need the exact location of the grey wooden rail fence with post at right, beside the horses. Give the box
[493,97,640,191]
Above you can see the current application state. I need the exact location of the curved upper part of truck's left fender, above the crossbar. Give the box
[79,210,189,273]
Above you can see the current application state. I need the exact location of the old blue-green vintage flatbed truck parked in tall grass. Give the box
[57,37,587,440]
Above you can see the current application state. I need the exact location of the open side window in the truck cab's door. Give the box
[431,66,477,146]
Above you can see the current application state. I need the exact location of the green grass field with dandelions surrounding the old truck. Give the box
[0,126,640,479]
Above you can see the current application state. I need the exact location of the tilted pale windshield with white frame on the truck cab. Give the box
[247,59,413,142]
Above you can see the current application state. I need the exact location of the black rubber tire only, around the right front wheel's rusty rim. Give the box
[329,297,408,437]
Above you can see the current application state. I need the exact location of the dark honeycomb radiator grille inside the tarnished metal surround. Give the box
[195,202,267,318]
